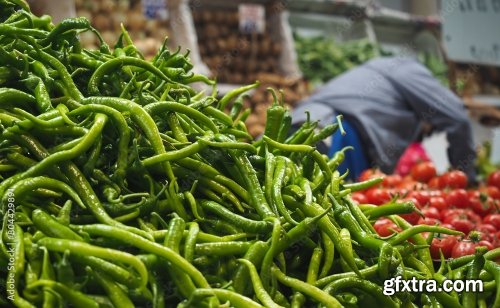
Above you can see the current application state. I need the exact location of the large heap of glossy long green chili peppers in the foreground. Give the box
[0,0,500,307]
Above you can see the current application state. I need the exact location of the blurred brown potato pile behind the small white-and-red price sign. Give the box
[193,8,282,84]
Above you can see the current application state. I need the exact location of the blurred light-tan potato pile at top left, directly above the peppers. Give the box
[75,0,170,58]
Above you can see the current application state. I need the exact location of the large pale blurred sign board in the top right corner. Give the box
[441,0,500,66]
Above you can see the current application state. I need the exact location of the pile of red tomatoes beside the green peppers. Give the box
[352,162,500,259]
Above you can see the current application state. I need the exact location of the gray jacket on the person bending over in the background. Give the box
[292,57,476,179]
